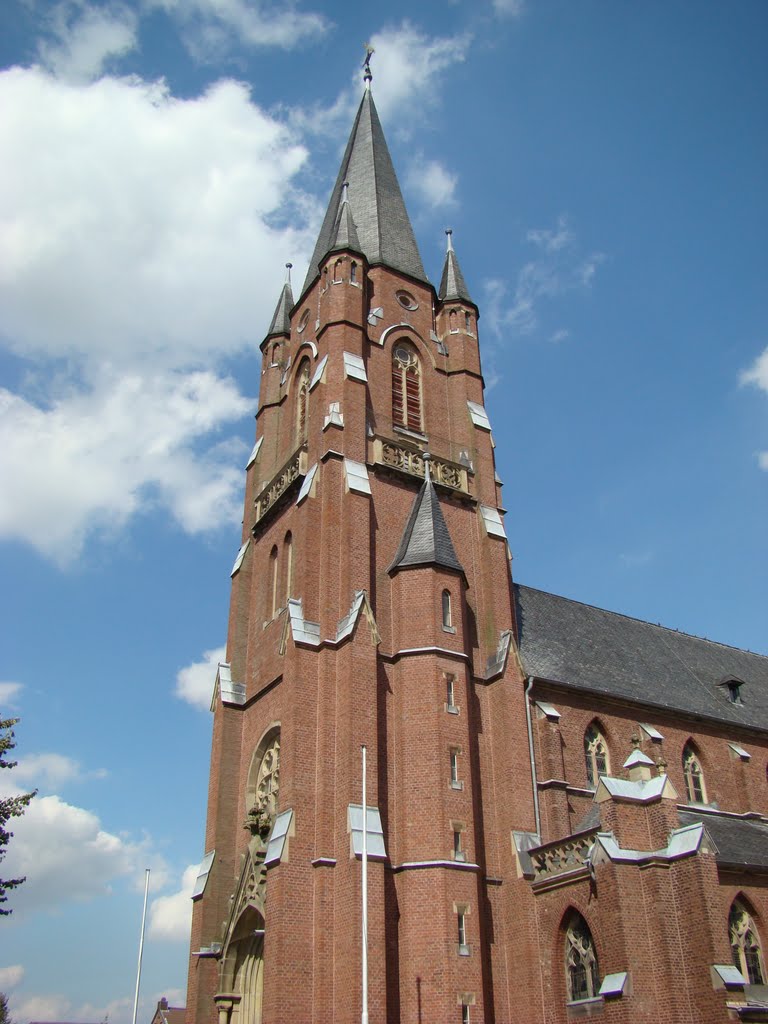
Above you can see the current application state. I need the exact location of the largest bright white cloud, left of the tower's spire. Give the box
[0,68,316,366]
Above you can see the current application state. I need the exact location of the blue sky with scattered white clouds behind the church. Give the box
[0,0,768,1024]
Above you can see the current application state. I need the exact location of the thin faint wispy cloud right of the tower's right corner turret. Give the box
[483,216,605,341]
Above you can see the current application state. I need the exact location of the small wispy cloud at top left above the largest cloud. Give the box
[38,0,137,82]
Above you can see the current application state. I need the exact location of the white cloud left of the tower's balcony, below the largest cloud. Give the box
[0,373,251,564]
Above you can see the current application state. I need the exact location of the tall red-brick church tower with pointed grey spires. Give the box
[188,72,534,1024]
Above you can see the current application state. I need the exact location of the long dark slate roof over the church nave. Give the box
[515,586,768,729]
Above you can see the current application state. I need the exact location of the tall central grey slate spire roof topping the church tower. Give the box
[302,88,428,293]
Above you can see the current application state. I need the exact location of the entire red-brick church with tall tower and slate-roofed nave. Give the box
[187,68,768,1024]
